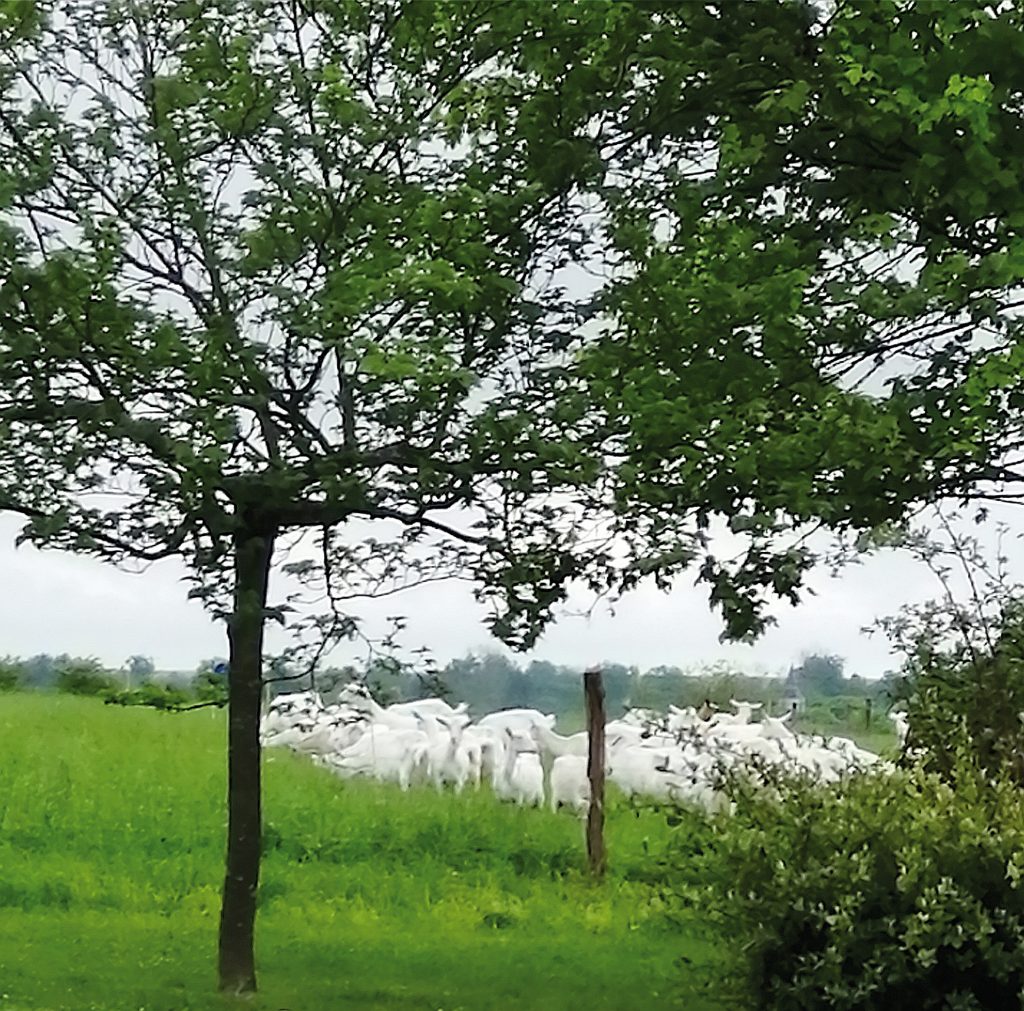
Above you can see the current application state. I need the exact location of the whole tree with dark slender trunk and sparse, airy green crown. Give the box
[0,0,647,992]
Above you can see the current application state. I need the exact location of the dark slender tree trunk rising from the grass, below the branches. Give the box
[218,529,274,994]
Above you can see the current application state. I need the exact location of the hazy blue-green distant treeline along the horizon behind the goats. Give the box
[0,652,891,716]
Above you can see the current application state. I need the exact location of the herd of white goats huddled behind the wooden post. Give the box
[261,683,892,812]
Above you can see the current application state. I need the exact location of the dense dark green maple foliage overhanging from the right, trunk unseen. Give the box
[585,0,1024,635]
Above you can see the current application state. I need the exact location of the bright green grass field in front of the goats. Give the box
[0,694,737,1011]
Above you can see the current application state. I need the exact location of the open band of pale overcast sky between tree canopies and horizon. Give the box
[0,503,1024,677]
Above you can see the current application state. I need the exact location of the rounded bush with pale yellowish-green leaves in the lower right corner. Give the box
[692,768,1024,1011]
